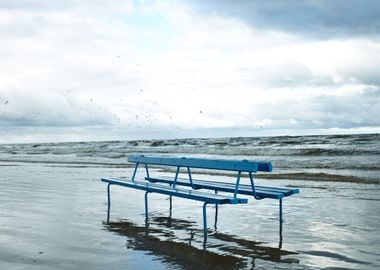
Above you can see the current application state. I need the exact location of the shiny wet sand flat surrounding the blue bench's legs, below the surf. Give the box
[0,162,380,269]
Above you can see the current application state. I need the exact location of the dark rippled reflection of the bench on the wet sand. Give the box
[104,217,298,269]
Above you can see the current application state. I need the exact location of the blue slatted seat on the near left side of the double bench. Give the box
[101,178,248,204]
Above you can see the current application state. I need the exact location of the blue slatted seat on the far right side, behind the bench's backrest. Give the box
[145,176,299,200]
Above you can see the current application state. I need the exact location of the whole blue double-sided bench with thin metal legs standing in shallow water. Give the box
[102,156,298,238]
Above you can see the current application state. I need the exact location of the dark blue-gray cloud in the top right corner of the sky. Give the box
[191,0,380,38]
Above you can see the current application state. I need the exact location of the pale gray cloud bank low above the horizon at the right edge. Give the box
[252,87,380,129]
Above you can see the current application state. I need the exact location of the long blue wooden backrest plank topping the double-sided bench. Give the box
[128,155,272,172]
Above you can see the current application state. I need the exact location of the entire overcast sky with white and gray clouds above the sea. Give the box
[0,0,380,143]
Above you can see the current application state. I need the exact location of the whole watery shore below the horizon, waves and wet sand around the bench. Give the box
[0,134,380,269]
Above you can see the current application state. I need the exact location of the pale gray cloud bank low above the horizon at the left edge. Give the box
[0,92,116,126]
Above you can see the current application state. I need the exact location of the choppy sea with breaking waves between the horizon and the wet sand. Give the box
[0,134,380,183]
